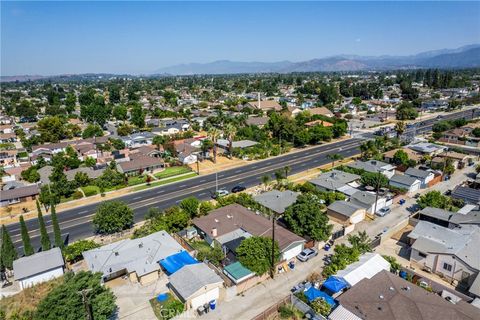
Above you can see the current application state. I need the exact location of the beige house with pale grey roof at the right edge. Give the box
[408,221,480,297]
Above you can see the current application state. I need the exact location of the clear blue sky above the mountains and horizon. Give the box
[0,1,480,76]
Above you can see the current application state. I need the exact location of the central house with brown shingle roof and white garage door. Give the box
[193,204,305,261]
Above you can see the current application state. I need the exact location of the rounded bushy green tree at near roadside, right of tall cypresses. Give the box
[93,201,133,234]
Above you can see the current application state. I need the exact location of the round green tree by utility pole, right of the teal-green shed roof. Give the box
[237,236,280,275]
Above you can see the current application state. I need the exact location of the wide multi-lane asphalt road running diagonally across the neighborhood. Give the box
[7,108,480,251]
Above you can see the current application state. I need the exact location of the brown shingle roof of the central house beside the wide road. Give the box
[193,204,304,250]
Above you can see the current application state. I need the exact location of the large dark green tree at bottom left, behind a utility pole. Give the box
[35,271,117,320]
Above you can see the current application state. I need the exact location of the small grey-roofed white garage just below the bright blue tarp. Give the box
[169,263,223,310]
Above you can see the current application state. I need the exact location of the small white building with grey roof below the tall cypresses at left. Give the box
[13,248,65,290]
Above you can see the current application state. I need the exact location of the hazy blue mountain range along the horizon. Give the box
[152,44,480,75]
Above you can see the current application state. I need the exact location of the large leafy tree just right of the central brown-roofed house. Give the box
[283,194,333,241]
